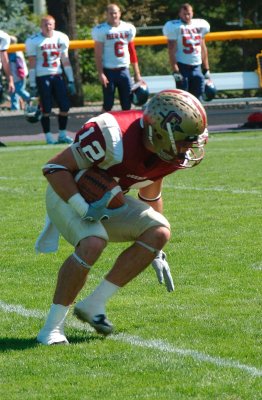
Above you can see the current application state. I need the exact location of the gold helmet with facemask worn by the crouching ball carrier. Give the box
[143,89,208,168]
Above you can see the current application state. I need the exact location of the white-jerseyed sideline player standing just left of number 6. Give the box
[25,15,75,144]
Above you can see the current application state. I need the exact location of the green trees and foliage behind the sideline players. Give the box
[0,0,262,105]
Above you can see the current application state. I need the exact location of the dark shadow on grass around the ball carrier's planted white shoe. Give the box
[0,334,105,353]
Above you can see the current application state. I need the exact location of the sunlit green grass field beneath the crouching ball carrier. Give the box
[0,132,262,400]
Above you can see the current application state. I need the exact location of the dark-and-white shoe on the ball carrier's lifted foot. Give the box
[74,301,114,336]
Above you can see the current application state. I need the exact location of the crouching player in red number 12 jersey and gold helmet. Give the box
[36,89,208,345]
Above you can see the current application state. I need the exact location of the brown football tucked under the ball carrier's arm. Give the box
[75,167,125,209]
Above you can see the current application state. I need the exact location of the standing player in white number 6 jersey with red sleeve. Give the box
[92,4,141,111]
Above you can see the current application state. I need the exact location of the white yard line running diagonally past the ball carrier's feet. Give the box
[0,300,262,377]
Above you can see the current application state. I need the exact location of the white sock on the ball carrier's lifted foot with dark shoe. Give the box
[81,279,120,316]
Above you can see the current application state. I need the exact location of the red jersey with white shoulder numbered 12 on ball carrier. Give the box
[72,110,181,191]
